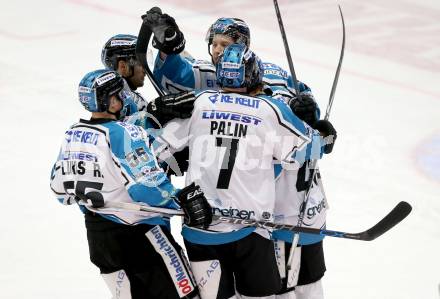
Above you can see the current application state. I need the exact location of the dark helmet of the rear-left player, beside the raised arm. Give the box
[101,34,137,70]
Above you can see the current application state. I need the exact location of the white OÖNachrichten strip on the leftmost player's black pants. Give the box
[145,225,194,298]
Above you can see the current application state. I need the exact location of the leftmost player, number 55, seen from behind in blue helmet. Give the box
[50,70,211,299]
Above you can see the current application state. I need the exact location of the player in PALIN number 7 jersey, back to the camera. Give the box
[151,44,321,299]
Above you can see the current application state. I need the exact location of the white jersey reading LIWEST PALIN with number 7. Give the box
[157,91,320,244]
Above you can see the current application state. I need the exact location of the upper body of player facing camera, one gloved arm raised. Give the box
[142,7,319,123]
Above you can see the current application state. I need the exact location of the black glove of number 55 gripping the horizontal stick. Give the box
[177,183,212,229]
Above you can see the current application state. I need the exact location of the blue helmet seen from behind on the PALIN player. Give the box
[216,44,263,90]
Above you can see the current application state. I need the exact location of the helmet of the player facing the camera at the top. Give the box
[205,18,251,47]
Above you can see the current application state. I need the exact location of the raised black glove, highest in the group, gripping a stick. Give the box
[142,7,185,55]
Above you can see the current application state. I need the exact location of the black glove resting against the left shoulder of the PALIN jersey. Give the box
[147,91,196,126]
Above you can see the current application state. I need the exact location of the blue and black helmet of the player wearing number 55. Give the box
[78,69,126,112]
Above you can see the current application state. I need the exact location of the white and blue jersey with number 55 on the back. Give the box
[50,119,179,225]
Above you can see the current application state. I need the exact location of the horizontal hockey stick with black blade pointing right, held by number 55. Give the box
[93,201,412,241]
